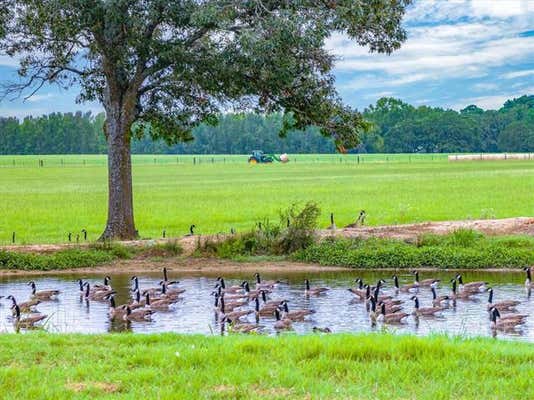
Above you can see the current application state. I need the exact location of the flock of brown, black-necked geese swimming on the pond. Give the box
[0,268,534,333]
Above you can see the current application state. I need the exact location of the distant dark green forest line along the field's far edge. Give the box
[0,96,534,154]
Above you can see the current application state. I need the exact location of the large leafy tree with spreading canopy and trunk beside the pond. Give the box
[0,0,410,239]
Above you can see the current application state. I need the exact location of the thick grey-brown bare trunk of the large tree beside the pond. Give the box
[100,108,138,240]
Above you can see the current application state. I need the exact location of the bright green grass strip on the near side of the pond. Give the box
[0,334,534,399]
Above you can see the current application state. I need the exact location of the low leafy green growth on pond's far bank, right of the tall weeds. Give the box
[293,231,534,268]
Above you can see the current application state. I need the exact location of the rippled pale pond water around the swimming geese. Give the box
[0,270,534,341]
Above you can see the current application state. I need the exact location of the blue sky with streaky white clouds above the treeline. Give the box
[0,0,534,118]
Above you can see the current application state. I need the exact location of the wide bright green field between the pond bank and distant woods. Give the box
[0,155,534,244]
